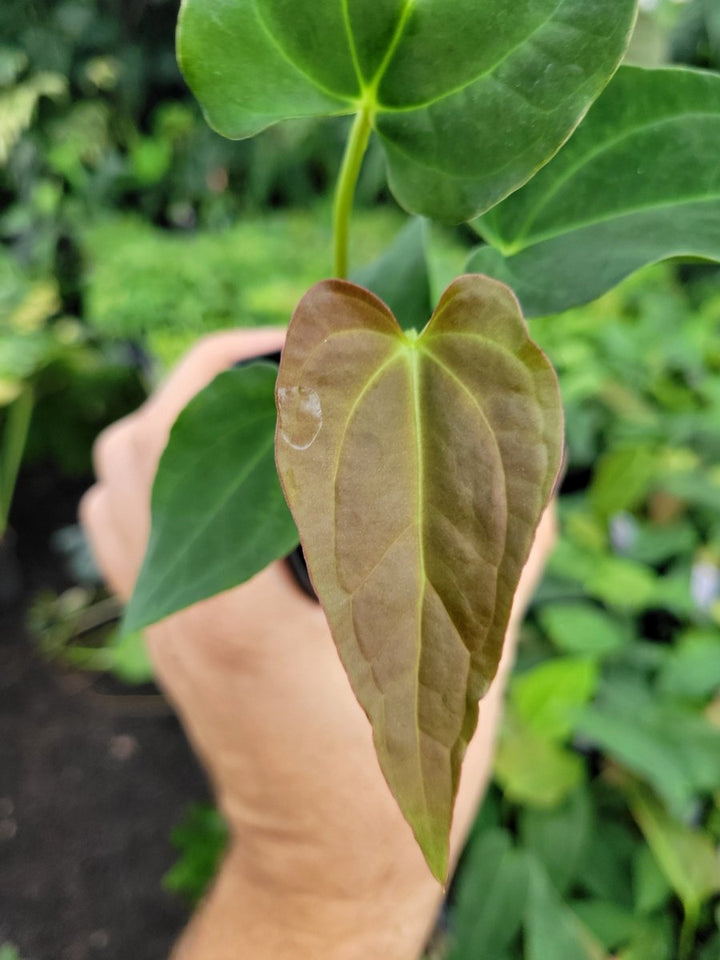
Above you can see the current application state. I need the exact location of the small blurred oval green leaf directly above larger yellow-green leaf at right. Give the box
[538,602,627,657]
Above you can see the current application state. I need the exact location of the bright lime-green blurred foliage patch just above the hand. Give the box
[82,206,410,364]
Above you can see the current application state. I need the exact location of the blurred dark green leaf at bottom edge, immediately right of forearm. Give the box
[448,830,529,960]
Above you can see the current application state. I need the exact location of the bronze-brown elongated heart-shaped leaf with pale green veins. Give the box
[277,276,562,878]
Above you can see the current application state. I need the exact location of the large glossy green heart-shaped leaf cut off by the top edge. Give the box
[178,0,635,220]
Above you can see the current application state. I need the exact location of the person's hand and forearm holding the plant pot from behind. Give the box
[81,330,554,960]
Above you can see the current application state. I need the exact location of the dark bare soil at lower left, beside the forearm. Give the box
[0,470,208,960]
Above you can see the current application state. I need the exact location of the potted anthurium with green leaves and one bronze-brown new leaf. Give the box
[127,0,720,881]
